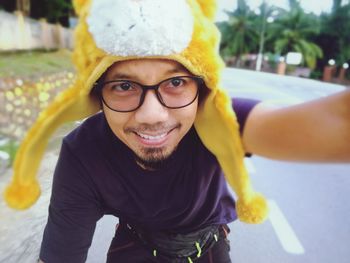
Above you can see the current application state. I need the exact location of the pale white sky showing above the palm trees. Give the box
[216,0,349,21]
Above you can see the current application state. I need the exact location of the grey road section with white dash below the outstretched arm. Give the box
[231,157,350,263]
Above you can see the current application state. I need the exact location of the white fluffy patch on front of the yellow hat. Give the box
[87,0,194,57]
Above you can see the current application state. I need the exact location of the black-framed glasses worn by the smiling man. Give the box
[97,76,204,112]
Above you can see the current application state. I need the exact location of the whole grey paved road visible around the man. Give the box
[0,69,350,263]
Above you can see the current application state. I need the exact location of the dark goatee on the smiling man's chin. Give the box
[135,144,176,171]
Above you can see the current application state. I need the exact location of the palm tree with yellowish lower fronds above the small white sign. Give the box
[269,3,323,69]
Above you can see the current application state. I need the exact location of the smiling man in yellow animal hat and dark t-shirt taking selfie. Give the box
[6,0,350,263]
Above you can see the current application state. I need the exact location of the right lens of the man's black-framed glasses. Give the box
[158,77,198,108]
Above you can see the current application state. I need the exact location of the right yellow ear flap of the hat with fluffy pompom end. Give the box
[195,89,268,224]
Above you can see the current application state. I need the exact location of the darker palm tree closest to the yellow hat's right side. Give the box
[218,0,258,66]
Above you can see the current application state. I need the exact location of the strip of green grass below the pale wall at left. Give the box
[0,49,74,78]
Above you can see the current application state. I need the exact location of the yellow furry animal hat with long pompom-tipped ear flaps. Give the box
[5,0,268,223]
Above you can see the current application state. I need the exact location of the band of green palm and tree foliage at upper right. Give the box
[218,0,350,73]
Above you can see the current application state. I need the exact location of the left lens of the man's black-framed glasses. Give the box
[102,80,142,111]
